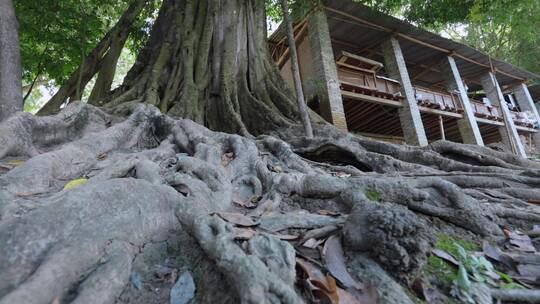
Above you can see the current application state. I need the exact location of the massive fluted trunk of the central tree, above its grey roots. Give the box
[102,0,299,135]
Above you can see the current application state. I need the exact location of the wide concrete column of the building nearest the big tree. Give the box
[305,10,347,130]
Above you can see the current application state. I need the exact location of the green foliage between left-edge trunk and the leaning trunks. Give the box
[14,0,160,85]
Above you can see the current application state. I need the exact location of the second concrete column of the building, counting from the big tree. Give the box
[381,37,428,146]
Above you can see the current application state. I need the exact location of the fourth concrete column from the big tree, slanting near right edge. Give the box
[481,72,527,157]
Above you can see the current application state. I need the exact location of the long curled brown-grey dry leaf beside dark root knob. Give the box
[322,235,363,290]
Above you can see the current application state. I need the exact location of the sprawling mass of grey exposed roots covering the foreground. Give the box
[0,103,540,303]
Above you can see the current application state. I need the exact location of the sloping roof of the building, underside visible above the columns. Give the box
[269,0,540,89]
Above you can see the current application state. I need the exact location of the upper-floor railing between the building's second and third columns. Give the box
[414,86,463,113]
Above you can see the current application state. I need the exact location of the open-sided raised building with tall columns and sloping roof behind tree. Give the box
[269,0,540,157]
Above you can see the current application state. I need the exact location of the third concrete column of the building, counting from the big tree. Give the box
[442,56,484,146]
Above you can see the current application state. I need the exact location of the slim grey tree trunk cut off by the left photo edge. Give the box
[0,0,23,121]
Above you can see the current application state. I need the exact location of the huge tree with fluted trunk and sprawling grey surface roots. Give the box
[0,0,540,304]
